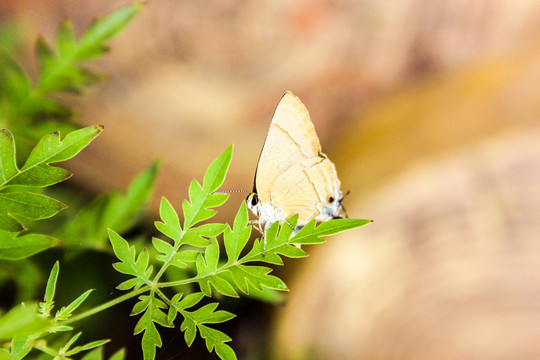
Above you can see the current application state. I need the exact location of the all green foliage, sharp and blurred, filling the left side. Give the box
[0,3,370,360]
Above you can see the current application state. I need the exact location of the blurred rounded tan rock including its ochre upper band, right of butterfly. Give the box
[273,47,540,360]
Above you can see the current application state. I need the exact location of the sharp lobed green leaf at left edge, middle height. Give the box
[0,126,103,260]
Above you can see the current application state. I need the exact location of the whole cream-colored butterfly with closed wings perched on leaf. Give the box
[246,92,343,243]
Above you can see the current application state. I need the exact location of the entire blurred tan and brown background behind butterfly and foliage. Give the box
[0,0,540,359]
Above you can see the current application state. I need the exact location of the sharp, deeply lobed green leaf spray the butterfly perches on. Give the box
[109,147,370,359]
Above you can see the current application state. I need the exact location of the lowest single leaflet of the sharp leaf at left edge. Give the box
[0,230,60,260]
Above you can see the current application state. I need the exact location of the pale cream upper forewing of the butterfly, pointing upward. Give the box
[254,92,321,202]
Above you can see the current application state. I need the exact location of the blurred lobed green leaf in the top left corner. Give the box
[0,3,142,139]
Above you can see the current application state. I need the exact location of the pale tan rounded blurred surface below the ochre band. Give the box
[273,127,540,359]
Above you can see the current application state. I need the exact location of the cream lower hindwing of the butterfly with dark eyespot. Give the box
[270,154,341,225]
